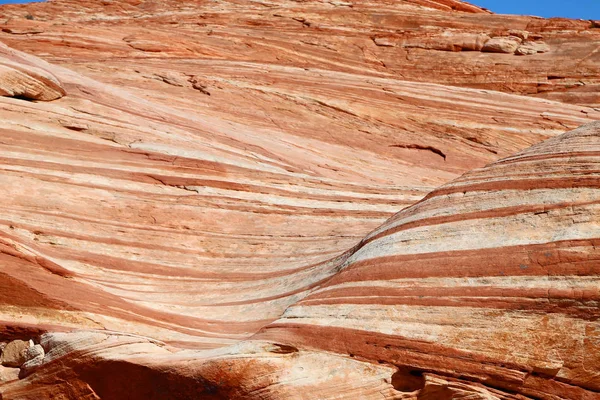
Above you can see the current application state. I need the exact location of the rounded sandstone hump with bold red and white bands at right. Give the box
[255,123,600,399]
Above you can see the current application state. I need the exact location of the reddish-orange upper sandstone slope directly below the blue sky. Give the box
[0,0,600,108]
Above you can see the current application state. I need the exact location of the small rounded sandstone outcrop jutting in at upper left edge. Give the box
[0,43,66,101]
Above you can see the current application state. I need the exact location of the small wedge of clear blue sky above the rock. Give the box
[469,0,600,19]
